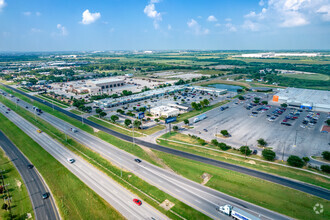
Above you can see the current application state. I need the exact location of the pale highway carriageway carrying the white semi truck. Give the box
[0,89,294,219]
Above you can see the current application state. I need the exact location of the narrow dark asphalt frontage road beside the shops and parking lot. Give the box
[2,84,330,200]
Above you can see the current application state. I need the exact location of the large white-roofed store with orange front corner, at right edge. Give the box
[273,88,330,112]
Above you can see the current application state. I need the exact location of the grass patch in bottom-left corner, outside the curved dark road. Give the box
[0,148,34,219]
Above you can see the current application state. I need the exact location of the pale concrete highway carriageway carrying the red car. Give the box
[0,105,168,219]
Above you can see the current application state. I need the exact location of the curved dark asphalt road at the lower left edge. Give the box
[0,130,60,220]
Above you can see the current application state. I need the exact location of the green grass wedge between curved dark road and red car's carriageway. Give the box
[0,114,124,220]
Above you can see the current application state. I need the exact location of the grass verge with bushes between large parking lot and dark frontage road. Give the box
[157,132,330,189]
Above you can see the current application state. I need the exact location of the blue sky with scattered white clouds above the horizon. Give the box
[0,0,330,52]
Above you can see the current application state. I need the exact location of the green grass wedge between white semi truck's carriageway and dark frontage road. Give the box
[155,151,330,220]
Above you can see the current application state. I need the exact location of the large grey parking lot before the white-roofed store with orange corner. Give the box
[183,94,330,159]
